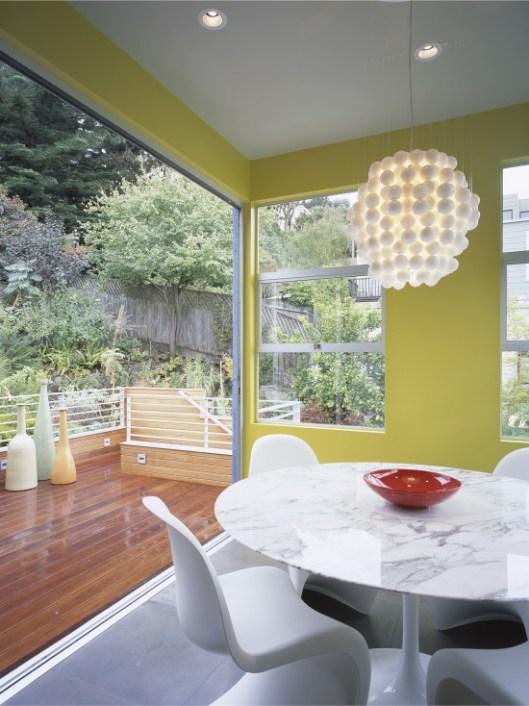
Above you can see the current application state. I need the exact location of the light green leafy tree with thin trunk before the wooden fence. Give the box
[85,167,232,354]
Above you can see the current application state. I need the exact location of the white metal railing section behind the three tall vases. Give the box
[0,388,125,448]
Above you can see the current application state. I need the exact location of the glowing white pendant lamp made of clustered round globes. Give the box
[350,149,479,289]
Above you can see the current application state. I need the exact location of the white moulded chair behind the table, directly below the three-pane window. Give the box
[249,434,377,614]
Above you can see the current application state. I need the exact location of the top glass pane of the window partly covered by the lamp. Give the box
[259,192,359,272]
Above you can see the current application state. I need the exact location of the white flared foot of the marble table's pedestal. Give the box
[368,648,430,706]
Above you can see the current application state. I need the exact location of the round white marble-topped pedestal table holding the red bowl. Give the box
[215,463,529,704]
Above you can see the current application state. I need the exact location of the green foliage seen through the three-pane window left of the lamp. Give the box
[259,197,384,428]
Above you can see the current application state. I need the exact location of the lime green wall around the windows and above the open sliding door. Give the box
[0,2,529,470]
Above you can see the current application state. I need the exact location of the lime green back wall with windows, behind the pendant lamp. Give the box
[243,104,529,470]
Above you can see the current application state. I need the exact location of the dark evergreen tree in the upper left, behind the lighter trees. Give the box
[0,62,141,232]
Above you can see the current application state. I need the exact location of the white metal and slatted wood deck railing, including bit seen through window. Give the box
[0,387,302,454]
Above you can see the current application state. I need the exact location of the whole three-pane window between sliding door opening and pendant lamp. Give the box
[257,193,384,429]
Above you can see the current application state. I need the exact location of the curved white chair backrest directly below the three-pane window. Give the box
[249,434,319,476]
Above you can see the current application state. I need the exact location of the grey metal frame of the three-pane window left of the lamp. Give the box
[254,201,386,426]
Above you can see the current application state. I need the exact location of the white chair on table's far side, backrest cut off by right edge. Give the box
[427,448,529,630]
